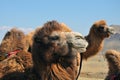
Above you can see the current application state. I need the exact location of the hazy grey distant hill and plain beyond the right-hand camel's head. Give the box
[103,25,120,51]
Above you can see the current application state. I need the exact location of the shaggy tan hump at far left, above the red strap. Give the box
[0,28,26,60]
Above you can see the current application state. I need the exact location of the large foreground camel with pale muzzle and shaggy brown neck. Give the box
[0,21,88,80]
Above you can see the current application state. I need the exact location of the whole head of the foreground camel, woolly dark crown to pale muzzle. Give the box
[32,21,88,61]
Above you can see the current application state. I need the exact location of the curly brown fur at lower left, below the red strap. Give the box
[0,51,32,78]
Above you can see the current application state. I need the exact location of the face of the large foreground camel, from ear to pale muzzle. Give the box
[35,31,88,56]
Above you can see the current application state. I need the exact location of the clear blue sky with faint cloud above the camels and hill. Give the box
[0,0,120,41]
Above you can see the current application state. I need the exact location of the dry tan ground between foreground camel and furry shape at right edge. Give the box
[78,54,108,80]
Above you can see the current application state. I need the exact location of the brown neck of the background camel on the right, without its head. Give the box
[83,35,104,59]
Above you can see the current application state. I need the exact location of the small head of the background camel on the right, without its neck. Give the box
[90,20,114,38]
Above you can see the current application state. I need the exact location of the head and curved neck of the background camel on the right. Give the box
[83,20,113,59]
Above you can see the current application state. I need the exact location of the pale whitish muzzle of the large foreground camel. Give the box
[63,32,88,52]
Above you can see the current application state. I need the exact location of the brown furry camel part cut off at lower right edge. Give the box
[105,50,120,80]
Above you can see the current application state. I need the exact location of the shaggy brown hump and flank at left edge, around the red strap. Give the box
[0,28,32,77]
